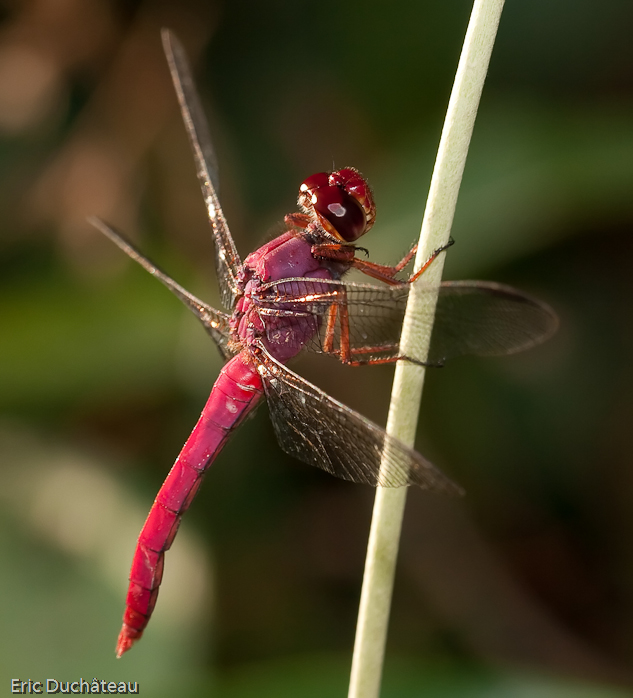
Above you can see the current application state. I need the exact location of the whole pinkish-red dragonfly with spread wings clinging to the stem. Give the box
[90,30,558,657]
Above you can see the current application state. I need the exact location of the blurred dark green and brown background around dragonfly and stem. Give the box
[0,0,633,698]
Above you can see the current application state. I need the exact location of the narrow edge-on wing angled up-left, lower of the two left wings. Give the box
[88,216,233,359]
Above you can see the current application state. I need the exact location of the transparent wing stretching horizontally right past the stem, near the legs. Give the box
[254,278,558,365]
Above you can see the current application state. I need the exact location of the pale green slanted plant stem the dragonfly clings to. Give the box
[348,0,504,698]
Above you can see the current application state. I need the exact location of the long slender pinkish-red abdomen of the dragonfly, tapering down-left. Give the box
[117,353,263,657]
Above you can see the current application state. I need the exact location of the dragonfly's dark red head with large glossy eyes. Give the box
[298,167,376,243]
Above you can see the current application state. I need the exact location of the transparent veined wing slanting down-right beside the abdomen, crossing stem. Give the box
[258,348,462,494]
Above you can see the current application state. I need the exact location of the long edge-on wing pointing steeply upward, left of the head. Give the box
[162,29,241,309]
